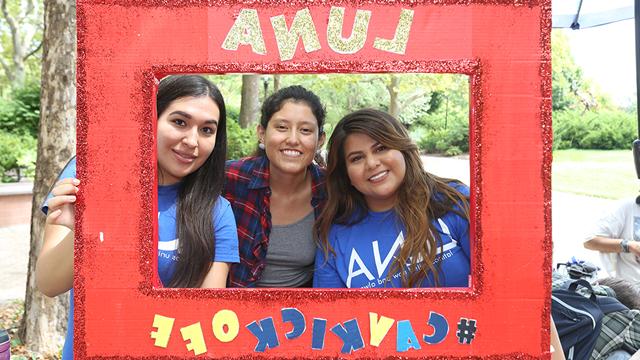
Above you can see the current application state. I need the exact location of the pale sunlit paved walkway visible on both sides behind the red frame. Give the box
[0,157,615,303]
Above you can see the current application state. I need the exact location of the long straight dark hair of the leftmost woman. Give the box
[157,75,227,287]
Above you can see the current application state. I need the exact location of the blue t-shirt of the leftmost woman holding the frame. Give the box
[42,157,240,360]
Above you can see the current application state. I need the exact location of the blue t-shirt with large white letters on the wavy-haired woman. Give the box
[313,188,471,289]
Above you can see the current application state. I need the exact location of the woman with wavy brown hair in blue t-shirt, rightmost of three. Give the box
[313,109,470,288]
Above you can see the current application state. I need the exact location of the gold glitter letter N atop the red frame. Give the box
[271,8,320,61]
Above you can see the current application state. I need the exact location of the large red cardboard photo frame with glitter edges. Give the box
[74,0,552,359]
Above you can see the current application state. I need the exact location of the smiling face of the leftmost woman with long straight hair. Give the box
[157,96,220,185]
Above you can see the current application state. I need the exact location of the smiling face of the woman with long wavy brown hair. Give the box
[344,133,406,211]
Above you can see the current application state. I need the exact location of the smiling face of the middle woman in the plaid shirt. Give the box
[258,101,324,175]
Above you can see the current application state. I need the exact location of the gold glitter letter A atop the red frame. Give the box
[222,9,267,55]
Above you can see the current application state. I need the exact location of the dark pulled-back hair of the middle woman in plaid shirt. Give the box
[254,85,327,167]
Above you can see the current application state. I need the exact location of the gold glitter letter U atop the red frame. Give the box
[327,6,371,54]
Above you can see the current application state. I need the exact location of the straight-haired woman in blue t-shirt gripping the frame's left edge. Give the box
[36,75,239,359]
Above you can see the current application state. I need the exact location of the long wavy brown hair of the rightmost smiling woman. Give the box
[316,109,469,287]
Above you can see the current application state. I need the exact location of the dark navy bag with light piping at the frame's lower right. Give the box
[551,279,627,360]
